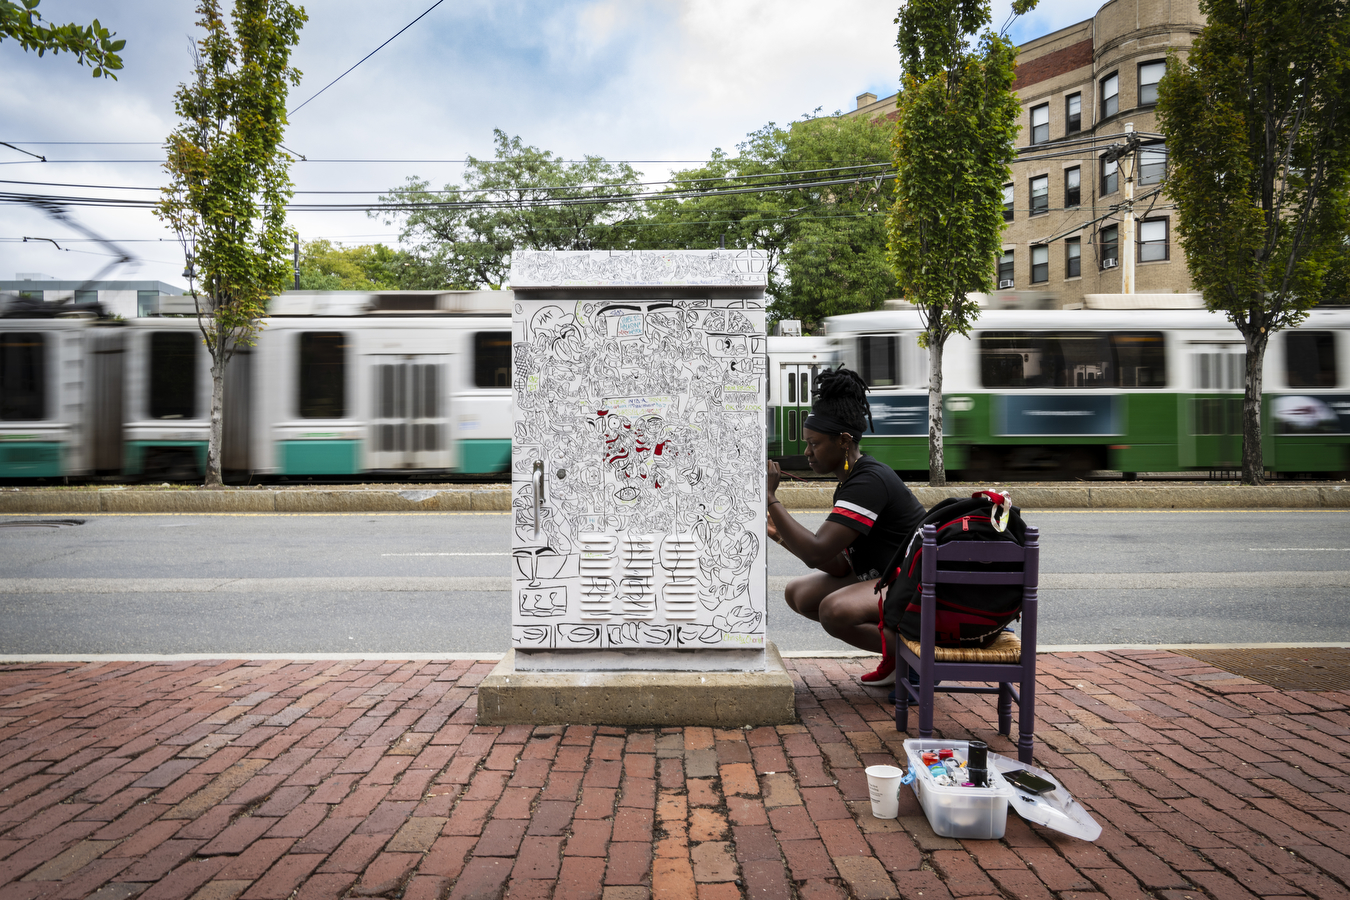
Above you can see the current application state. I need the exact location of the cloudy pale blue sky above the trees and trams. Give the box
[0,0,1096,287]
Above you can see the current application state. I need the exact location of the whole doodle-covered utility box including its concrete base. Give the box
[479,250,792,725]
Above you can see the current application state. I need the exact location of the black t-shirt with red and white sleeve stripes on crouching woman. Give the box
[826,456,927,578]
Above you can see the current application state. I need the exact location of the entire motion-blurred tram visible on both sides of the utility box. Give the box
[0,290,1350,480]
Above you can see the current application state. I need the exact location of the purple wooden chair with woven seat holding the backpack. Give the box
[895,525,1041,762]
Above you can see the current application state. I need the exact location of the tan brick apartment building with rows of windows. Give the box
[845,0,1204,306]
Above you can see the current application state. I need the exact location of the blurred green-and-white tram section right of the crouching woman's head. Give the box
[825,298,1350,480]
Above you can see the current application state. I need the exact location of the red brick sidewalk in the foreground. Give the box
[0,652,1350,900]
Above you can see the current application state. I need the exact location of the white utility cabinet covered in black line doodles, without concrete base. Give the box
[512,292,767,649]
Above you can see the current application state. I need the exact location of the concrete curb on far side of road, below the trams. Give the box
[0,482,1350,515]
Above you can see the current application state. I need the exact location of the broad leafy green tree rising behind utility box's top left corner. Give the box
[370,130,640,289]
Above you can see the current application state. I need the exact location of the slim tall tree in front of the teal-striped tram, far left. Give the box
[157,0,306,486]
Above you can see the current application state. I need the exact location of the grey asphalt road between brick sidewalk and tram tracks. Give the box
[0,510,1350,658]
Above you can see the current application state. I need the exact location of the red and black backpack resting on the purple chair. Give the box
[876,491,1026,646]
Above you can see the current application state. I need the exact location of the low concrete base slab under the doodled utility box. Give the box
[478,644,797,729]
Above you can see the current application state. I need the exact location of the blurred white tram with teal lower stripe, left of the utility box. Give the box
[0,290,512,480]
